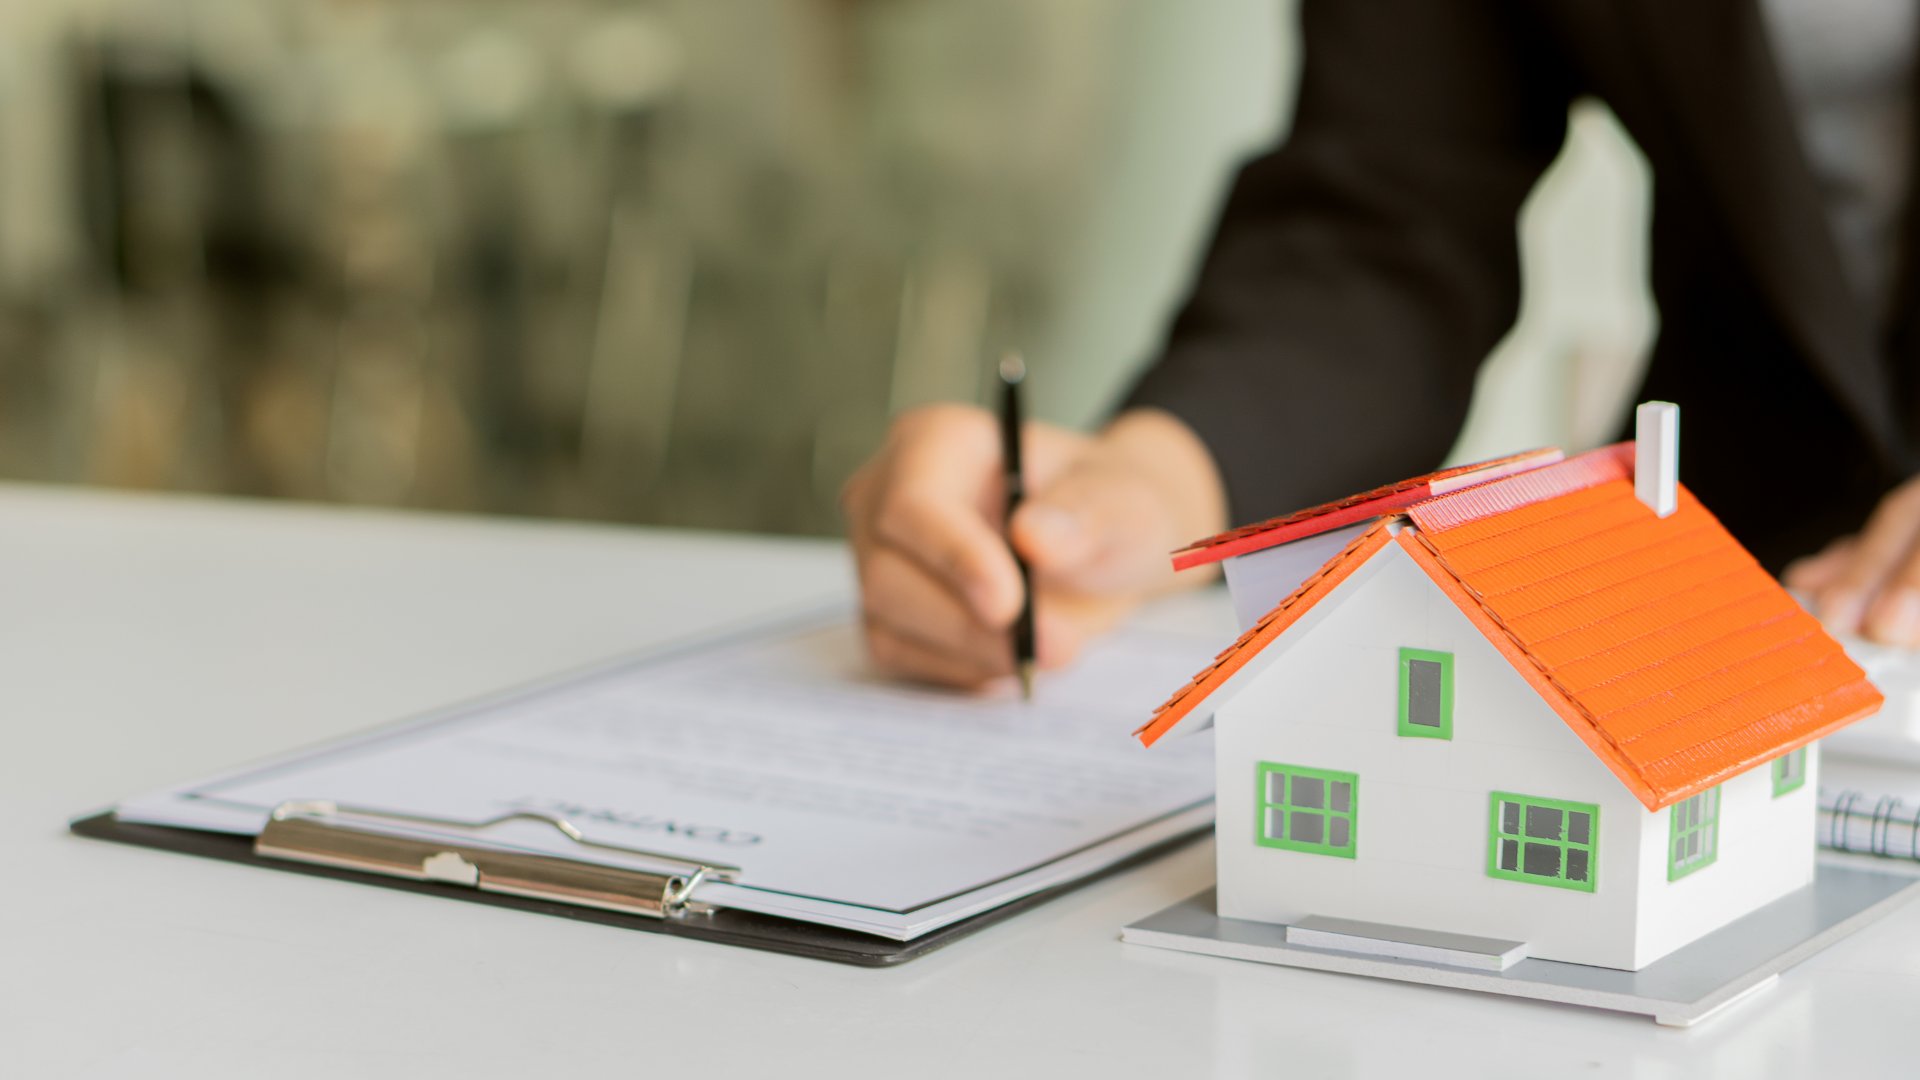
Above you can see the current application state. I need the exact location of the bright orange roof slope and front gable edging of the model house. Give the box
[1139,440,1882,809]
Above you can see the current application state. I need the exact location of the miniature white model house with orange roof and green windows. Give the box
[1137,404,1882,970]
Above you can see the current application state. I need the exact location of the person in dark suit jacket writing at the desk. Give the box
[843,0,1920,686]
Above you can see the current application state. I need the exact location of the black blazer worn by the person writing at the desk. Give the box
[1129,0,1914,569]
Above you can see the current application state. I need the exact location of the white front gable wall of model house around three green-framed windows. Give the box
[1215,544,1651,969]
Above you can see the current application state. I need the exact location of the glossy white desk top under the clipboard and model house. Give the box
[11,486,1920,1080]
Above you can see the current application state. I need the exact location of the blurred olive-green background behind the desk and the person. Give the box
[0,0,1653,532]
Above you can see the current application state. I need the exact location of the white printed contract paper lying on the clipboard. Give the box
[117,615,1219,940]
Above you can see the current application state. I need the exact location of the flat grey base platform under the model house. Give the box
[1119,863,1920,1028]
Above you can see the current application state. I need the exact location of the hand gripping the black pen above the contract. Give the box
[841,405,1225,688]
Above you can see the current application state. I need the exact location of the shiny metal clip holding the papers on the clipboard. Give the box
[253,799,739,919]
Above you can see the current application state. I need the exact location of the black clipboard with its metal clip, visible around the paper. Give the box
[69,803,1210,967]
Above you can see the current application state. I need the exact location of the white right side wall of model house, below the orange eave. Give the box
[1640,746,1820,965]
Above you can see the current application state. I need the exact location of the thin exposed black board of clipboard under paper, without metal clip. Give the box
[69,811,1212,967]
